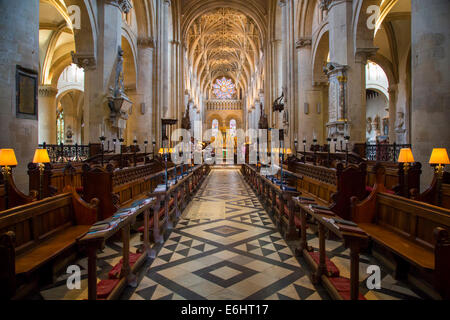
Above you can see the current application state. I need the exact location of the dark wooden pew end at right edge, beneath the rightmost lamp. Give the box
[411,172,450,209]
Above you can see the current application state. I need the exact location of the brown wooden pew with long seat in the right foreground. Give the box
[352,167,450,299]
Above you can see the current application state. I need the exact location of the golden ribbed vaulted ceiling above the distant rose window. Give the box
[186,8,262,99]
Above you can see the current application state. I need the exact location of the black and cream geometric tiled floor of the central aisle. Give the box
[37,168,428,300]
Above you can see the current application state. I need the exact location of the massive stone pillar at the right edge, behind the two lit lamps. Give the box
[411,0,450,188]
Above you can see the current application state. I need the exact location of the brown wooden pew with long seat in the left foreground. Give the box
[0,186,98,299]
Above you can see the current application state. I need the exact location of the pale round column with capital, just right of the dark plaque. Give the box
[39,86,58,144]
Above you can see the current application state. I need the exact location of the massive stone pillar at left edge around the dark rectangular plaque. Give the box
[0,0,39,192]
